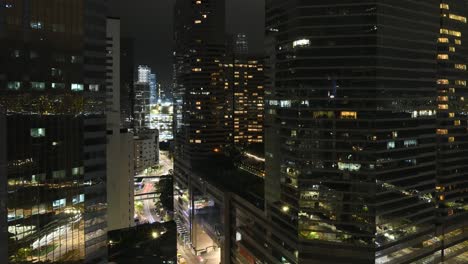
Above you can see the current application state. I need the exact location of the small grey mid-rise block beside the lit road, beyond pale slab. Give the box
[134,129,159,175]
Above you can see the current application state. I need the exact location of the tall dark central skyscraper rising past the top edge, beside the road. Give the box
[174,0,232,256]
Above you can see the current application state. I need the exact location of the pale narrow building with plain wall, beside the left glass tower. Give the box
[106,18,134,230]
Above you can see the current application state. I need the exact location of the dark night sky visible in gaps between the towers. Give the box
[110,0,265,85]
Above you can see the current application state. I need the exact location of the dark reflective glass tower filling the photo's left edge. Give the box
[0,0,107,263]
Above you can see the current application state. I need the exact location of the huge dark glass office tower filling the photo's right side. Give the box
[265,0,468,263]
